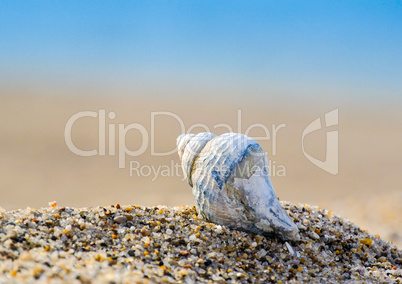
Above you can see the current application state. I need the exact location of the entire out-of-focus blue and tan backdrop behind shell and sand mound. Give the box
[0,1,402,247]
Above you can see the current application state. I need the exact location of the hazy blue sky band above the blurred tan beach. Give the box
[0,1,402,99]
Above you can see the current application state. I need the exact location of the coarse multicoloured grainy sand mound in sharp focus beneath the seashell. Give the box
[0,202,402,283]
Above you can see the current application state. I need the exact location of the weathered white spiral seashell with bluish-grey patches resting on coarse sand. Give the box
[177,132,299,240]
